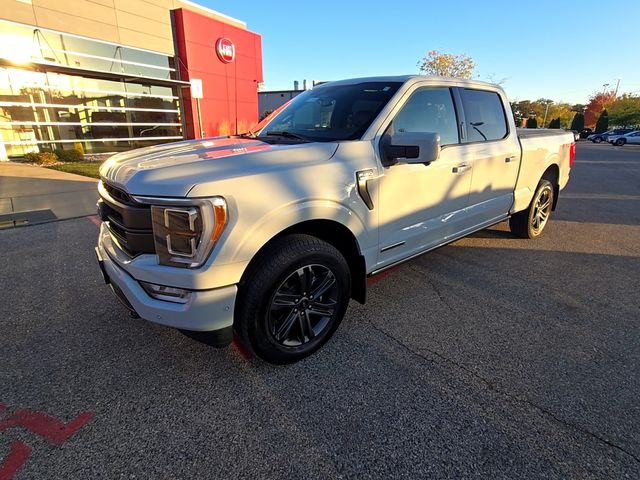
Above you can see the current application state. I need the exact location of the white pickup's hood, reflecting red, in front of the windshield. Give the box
[100,137,338,197]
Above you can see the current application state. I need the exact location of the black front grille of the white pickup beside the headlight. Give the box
[98,180,156,257]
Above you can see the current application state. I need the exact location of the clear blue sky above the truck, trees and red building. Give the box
[201,0,640,103]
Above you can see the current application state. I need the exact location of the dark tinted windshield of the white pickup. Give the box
[258,82,402,142]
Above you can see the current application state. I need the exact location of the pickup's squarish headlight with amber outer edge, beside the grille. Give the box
[136,197,227,268]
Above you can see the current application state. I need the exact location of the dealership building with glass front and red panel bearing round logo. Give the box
[0,0,263,160]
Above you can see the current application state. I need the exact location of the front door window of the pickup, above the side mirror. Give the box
[386,88,459,145]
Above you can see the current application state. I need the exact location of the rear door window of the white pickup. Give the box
[460,88,508,142]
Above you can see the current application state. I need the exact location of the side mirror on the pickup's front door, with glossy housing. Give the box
[381,132,440,166]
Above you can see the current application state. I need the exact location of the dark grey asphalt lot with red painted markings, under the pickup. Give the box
[0,143,640,479]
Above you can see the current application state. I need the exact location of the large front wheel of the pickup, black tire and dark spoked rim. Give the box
[234,234,351,364]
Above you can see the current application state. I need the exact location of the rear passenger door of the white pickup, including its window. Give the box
[457,88,521,226]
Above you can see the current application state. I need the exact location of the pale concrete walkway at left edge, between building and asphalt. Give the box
[0,162,98,228]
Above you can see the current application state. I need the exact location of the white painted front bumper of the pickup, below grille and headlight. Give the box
[96,235,238,332]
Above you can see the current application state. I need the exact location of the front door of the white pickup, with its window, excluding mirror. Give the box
[378,87,472,267]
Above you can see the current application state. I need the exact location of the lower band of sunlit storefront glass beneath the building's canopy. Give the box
[0,68,183,157]
